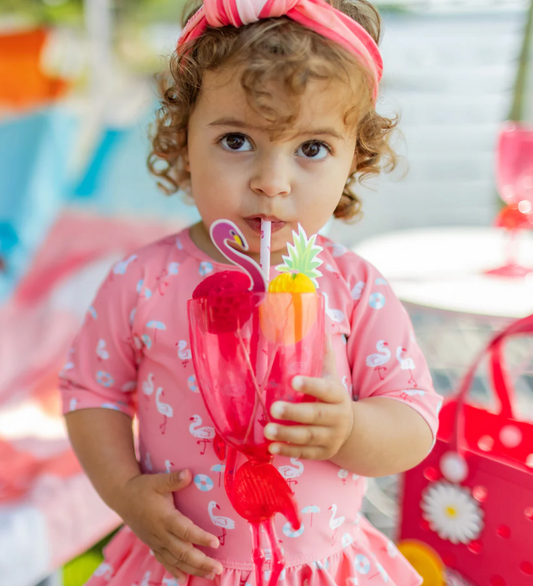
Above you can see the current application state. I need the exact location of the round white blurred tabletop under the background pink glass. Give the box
[354,228,533,319]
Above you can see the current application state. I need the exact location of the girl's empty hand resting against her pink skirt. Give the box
[118,470,223,581]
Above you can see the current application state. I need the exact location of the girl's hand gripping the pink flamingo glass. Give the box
[265,340,354,460]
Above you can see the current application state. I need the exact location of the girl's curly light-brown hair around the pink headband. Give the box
[148,0,397,220]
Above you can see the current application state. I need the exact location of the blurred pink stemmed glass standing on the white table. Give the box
[486,122,533,277]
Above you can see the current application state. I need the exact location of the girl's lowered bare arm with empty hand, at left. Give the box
[66,409,223,580]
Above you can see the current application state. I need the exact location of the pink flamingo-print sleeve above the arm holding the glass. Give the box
[347,263,442,439]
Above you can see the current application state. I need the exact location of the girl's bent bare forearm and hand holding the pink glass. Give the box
[265,346,432,477]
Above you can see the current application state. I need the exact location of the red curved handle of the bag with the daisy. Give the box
[451,314,533,455]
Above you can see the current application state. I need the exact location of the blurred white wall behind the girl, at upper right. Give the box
[330,6,526,246]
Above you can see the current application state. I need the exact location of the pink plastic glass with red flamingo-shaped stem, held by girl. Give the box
[188,291,324,586]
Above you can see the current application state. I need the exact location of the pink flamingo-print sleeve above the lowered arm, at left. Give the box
[60,255,142,417]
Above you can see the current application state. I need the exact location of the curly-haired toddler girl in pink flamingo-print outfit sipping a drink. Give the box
[62,0,441,586]
